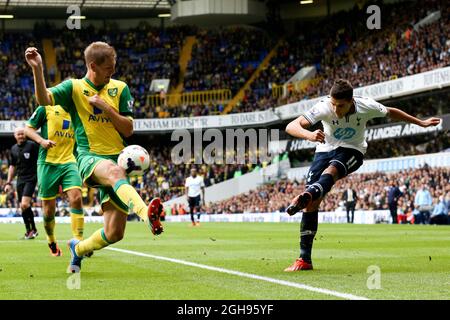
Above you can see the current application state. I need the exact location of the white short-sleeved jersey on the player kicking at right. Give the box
[303,96,387,154]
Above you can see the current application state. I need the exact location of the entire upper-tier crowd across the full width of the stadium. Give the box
[0,0,450,120]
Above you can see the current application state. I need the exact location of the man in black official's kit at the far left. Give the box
[5,128,39,239]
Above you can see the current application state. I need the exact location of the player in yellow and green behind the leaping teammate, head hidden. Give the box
[25,105,84,256]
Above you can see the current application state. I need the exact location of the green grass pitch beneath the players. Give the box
[0,222,450,300]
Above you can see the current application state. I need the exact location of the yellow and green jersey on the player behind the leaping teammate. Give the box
[26,105,75,164]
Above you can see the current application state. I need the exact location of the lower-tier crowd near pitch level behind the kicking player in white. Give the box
[198,166,450,224]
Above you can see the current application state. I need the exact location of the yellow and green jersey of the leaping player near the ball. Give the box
[49,78,133,155]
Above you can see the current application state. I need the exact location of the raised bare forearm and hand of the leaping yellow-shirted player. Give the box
[25,47,52,106]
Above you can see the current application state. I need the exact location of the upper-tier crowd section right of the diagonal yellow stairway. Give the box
[243,0,450,112]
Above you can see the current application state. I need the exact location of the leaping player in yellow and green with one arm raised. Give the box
[25,42,163,272]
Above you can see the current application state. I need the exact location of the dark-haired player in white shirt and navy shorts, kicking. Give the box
[284,79,441,271]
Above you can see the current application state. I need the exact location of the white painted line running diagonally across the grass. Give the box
[105,247,369,300]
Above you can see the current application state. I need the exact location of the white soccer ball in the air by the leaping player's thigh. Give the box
[117,144,150,177]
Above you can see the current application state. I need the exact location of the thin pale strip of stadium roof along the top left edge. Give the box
[0,0,170,9]
